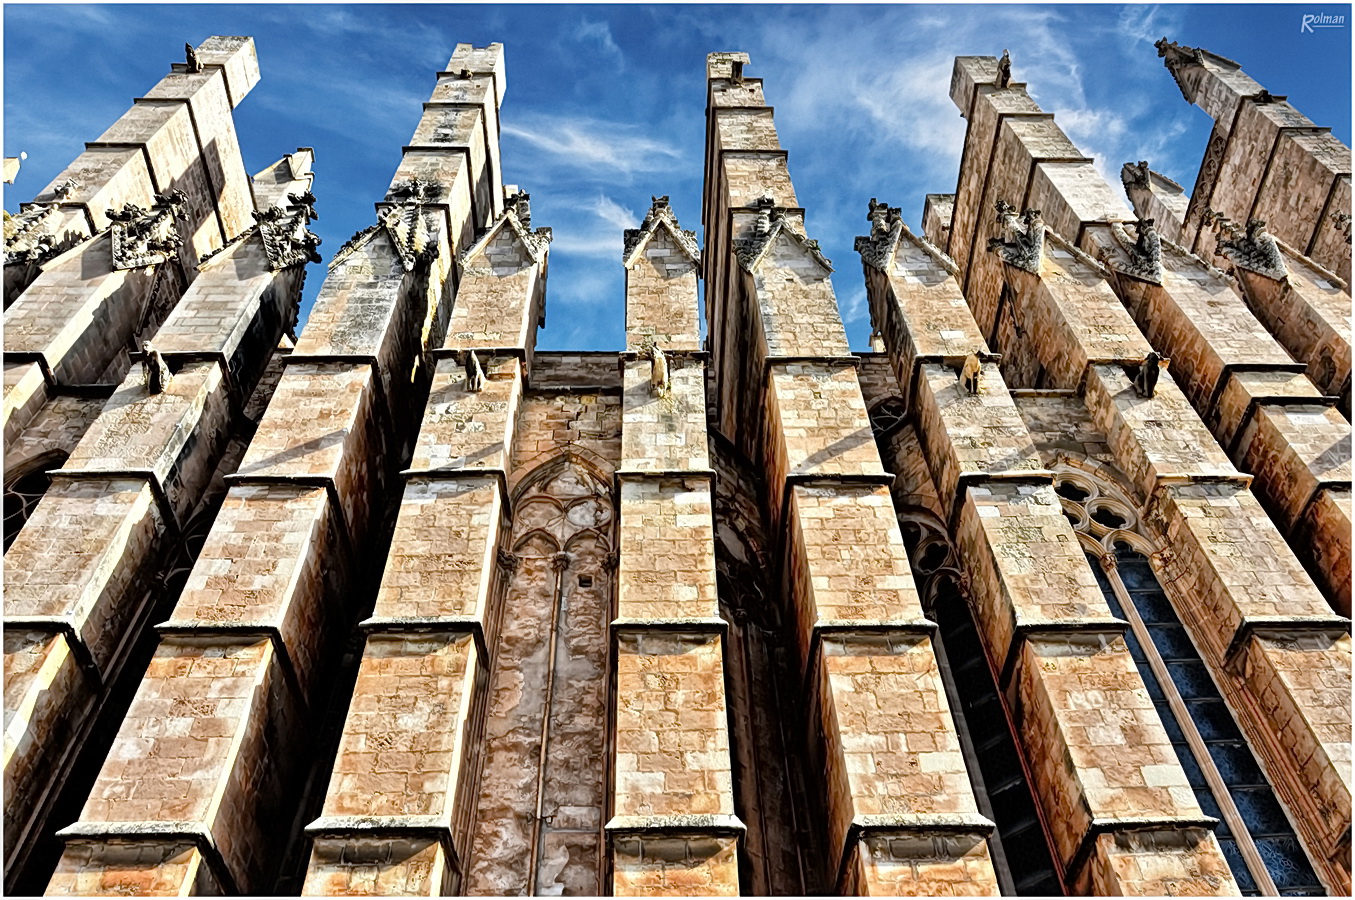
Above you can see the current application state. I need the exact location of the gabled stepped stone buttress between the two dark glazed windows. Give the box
[856,202,1237,895]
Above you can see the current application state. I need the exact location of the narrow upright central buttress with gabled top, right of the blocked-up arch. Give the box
[607,197,744,896]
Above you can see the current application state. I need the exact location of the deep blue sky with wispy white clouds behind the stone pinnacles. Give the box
[4,3,1351,350]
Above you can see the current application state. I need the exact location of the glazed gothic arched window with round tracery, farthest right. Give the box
[1054,472,1325,897]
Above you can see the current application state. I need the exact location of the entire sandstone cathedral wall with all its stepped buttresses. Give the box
[4,31,1351,896]
